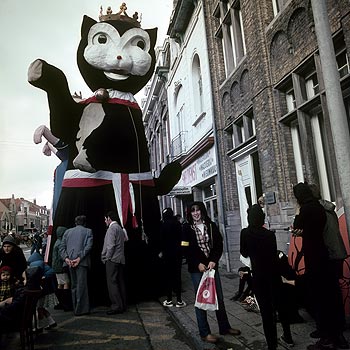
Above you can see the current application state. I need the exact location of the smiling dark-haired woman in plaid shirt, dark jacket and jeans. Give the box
[181,202,241,343]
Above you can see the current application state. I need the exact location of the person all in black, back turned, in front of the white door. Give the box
[240,204,294,350]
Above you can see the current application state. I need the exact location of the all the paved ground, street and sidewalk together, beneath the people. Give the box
[3,256,350,350]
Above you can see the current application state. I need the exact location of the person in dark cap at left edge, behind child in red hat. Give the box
[0,235,27,280]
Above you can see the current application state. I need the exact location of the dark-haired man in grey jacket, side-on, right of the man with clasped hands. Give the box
[101,211,127,315]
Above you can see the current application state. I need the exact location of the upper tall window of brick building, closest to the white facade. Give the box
[214,1,246,76]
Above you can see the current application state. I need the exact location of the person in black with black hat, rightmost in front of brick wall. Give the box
[293,183,343,350]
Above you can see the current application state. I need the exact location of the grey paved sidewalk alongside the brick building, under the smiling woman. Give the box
[162,265,350,350]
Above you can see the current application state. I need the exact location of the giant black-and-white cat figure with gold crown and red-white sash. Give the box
[28,3,181,303]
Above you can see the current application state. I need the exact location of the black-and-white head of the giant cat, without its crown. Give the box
[78,16,156,93]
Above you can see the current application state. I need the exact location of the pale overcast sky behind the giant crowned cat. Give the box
[0,0,173,208]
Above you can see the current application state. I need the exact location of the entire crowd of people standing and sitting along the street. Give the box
[0,189,349,350]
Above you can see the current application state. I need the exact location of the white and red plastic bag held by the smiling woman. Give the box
[194,269,219,311]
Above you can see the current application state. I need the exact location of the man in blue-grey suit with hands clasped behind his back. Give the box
[59,215,93,316]
